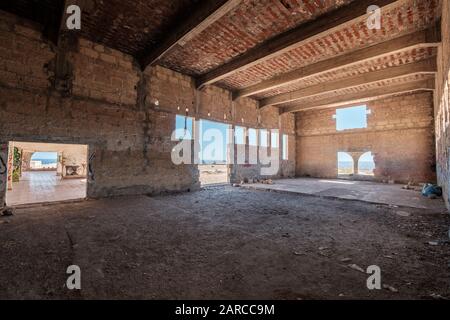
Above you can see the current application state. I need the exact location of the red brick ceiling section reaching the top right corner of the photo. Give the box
[209,0,438,89]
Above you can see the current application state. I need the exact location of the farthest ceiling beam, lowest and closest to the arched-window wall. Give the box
[282,79,435,113]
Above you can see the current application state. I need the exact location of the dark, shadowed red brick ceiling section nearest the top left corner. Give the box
[81,0,199,56]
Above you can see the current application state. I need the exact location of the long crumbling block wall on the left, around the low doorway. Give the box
[0,11,294,205]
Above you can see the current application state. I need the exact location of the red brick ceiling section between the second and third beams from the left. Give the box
[160,0,352,75]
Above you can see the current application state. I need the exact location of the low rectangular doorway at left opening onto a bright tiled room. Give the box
[6,141,88,206]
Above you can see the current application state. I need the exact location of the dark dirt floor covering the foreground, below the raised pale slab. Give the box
[0,186,450,299]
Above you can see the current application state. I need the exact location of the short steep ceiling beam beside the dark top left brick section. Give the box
[139,0,242,69]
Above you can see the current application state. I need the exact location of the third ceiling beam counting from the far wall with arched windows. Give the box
[237,28,440,99]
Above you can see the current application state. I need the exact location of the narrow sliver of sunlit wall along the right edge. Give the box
[434,1,450,207]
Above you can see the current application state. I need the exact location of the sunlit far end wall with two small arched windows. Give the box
[296,93,436,182]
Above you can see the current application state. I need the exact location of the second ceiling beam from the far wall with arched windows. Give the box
[260,57,437,108]
